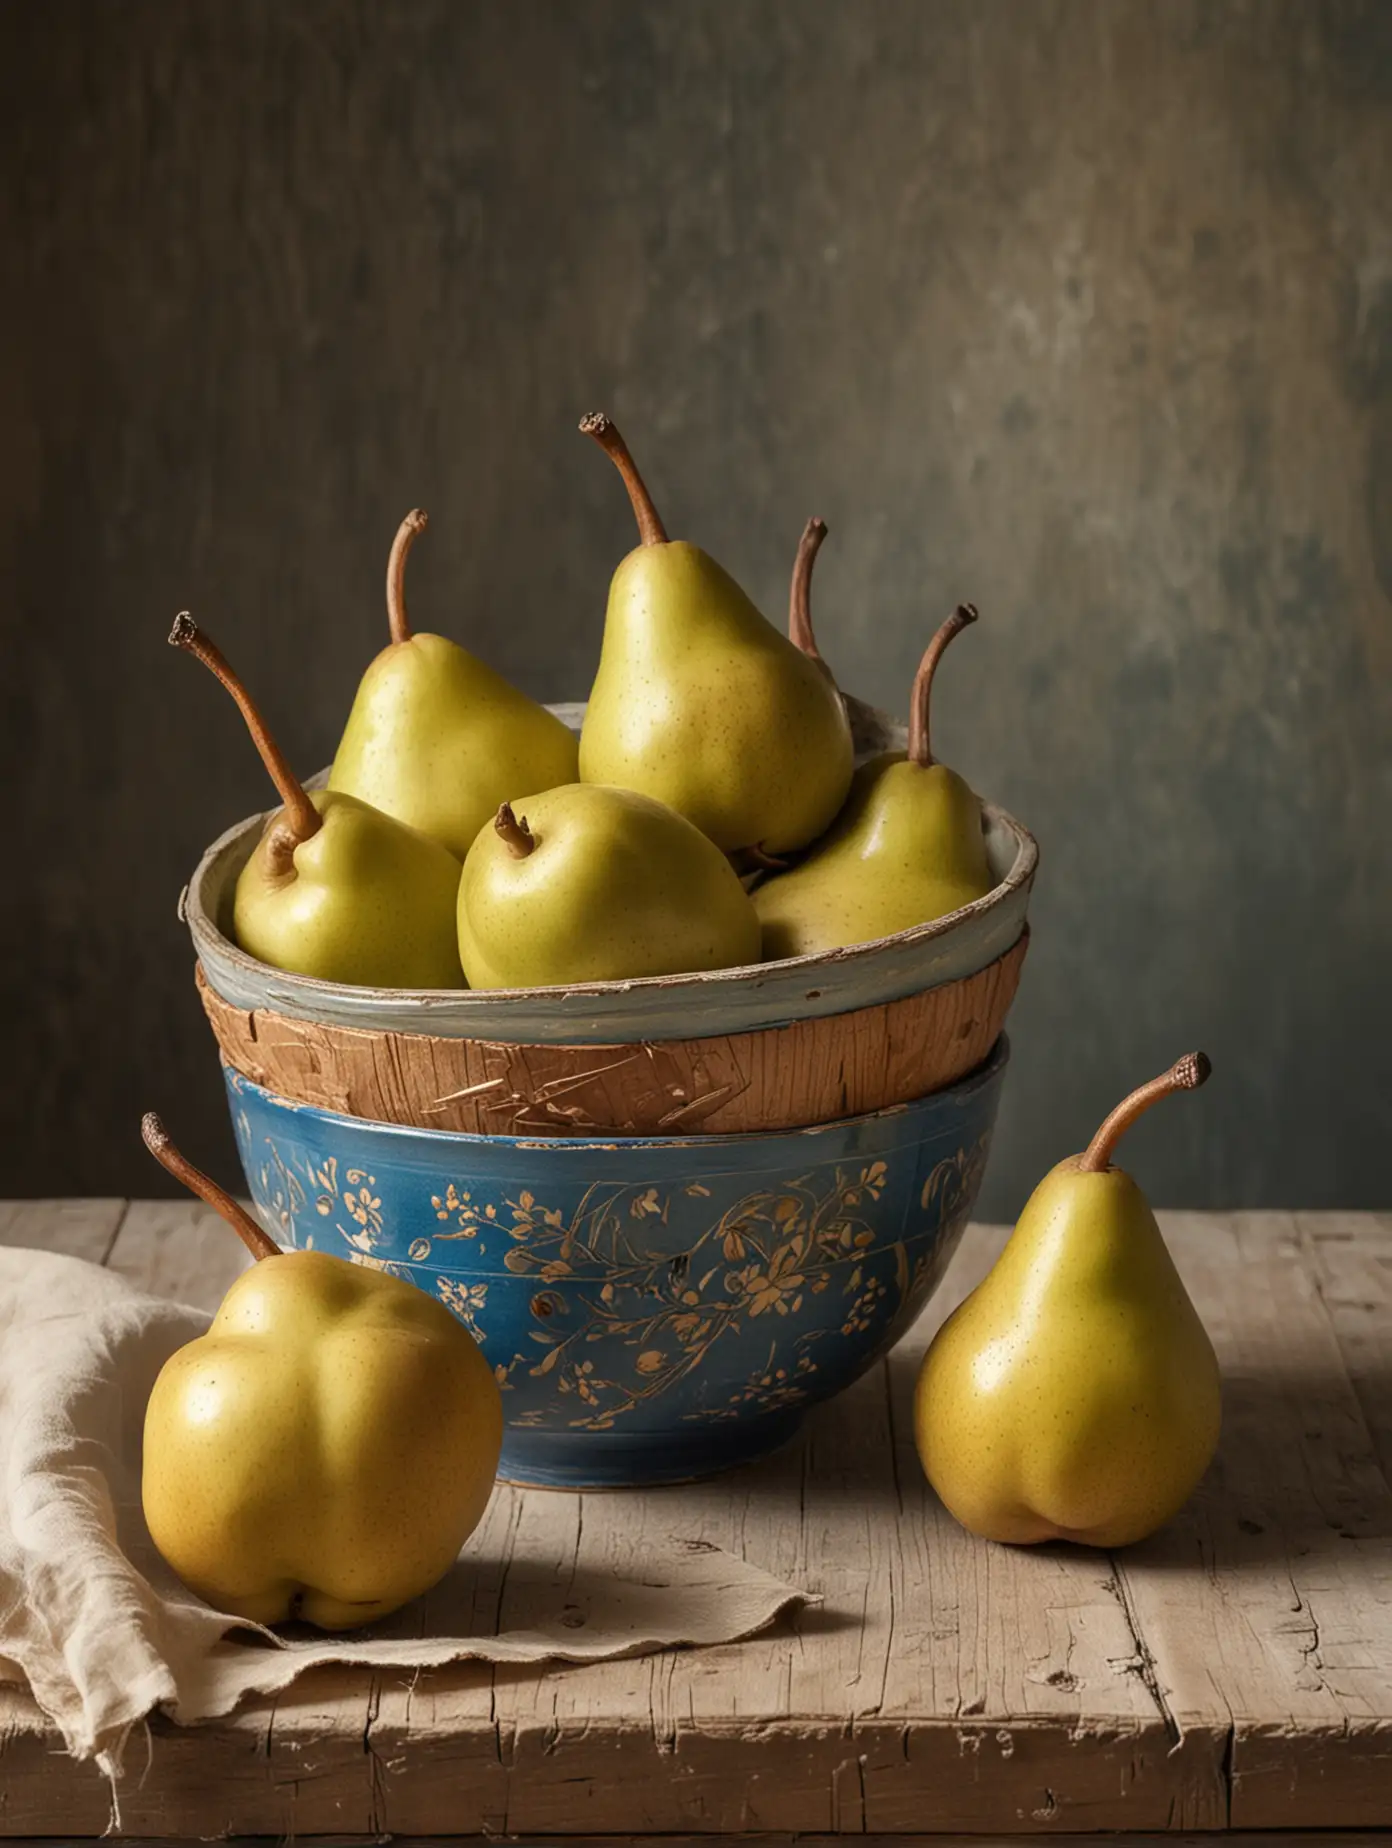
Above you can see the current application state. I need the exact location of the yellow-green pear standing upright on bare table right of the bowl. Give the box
[913,1052,1220,1547]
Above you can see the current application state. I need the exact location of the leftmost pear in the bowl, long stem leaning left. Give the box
[170,610,464,989]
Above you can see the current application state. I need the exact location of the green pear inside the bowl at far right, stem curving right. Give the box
[754,604,995,961]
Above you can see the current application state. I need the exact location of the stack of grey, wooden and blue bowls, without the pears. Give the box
[183,699,1037,1489]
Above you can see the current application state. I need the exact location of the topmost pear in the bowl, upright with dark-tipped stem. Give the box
[580,412,854,854]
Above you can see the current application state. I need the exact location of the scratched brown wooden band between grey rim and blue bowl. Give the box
[198,931,1028,1137]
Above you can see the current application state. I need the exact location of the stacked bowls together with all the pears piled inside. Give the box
[182,414,1037,1488]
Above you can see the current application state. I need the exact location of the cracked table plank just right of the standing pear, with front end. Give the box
[1117,1212,1392,1828]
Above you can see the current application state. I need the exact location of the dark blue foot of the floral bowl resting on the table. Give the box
[497,1406,806,1491]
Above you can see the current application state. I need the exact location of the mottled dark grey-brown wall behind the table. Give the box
[0,0,1392,1216]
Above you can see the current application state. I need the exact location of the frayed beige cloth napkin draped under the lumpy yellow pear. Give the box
[0,1249,806,1774]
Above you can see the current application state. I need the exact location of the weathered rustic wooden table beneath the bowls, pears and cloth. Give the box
[0,1199,1392,1848]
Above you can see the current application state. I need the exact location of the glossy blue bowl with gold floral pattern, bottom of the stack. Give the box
[224,1039,1009,1489]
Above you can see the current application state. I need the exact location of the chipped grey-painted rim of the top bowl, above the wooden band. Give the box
[179,699,1039,1064]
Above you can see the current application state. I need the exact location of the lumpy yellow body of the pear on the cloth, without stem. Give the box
[140,1251,503,1630]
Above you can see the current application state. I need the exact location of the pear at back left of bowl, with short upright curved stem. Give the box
[329,508,579,859]
